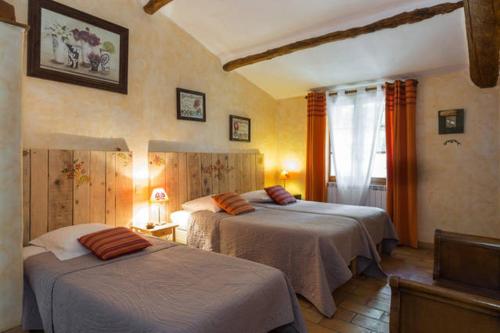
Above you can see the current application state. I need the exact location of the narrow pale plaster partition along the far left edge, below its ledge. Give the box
[0,22,24,332]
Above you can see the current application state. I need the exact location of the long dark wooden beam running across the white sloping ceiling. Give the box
[223,1,464,71]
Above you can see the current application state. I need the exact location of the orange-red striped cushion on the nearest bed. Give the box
[78,227,153,260]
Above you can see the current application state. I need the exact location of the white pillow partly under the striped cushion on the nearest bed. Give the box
[30,223,111,261]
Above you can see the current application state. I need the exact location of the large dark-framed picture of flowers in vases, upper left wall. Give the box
[28,0,128,94]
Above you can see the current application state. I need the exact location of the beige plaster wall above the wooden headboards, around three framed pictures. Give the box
[11,0,277,224]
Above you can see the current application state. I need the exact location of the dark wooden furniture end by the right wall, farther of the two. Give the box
[434,230,500,297]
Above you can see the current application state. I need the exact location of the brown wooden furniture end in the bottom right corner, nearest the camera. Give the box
[390,276,500,333]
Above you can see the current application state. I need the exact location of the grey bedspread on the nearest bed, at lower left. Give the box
[23,240,306,333]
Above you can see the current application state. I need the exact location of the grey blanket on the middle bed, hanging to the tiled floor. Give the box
[187,208,384,317]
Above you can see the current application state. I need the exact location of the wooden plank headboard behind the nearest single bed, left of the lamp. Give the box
[23,149,133,244]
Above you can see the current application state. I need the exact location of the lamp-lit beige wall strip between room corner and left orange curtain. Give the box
[276,96,307,197]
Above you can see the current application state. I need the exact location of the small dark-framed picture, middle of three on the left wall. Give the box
[177,88,207,121]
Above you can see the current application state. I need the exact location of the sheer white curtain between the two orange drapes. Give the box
[327,85,384,206]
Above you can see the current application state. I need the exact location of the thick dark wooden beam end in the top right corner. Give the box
[464,0,500,88]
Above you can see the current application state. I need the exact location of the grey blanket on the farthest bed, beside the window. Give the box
[251,200,399,254]
